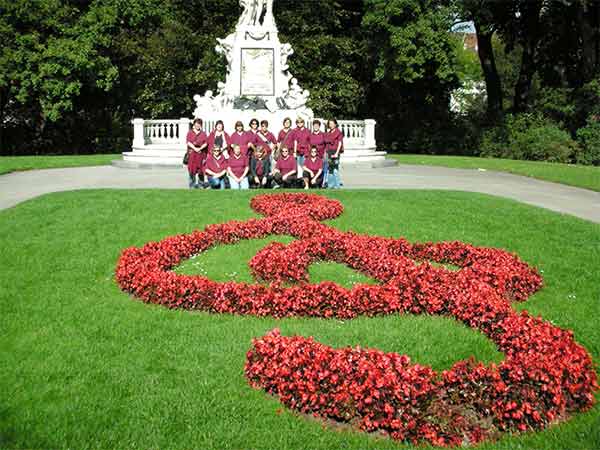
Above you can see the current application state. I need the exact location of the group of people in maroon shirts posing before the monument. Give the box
[184,118,344,189]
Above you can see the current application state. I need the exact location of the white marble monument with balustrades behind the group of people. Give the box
[122,0,385,167]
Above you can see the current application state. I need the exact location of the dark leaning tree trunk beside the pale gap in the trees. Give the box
[475,22,502,120]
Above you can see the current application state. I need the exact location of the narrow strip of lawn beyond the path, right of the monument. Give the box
[388,154,600,191]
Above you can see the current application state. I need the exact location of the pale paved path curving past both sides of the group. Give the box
[0,165,600,223]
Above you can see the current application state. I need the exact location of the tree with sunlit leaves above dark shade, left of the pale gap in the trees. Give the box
[362,0,459,150]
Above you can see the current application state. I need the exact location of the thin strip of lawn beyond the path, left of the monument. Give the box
[0,154,121,175]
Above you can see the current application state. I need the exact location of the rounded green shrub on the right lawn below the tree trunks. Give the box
[481,113,578,163]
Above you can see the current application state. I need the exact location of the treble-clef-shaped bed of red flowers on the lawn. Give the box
[116,194,598,445]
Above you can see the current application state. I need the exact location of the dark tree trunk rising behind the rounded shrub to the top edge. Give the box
[513,1,542,112]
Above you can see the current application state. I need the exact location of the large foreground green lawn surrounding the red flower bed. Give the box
[0,190,600,449]
